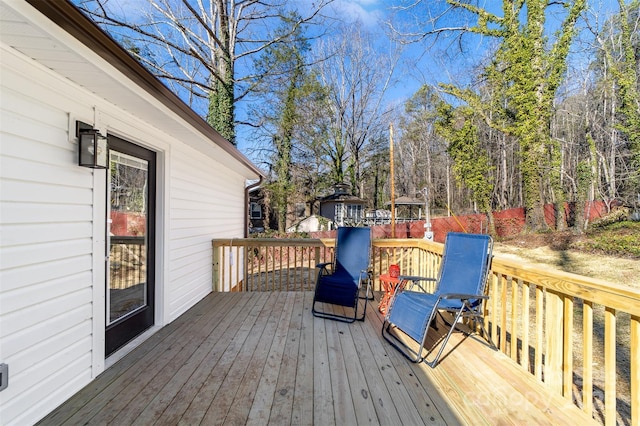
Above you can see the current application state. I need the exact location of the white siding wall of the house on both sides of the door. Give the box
[0,41,245,425]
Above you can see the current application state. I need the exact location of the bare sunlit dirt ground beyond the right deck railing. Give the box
[493,233,640,289]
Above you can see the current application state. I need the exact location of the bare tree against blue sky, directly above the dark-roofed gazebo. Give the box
[306,23,399,194]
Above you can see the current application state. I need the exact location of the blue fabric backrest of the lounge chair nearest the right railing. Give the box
[436,232,493,294]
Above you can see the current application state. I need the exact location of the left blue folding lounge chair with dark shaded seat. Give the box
[312,227,371,322]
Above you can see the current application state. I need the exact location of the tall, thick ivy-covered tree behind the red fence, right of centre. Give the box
[444,0,586,230]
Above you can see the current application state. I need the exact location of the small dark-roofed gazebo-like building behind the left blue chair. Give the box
[319,183,367,227]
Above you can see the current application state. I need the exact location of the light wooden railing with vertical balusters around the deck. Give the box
[213,239,640,425]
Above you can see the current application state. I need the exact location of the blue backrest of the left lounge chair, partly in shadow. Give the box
[333,226,371,282]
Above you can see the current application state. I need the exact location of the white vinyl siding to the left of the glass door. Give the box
[0,51,93,424]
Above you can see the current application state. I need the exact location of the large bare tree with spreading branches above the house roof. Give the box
[78,0,333,143]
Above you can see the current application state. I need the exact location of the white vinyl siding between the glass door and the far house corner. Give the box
[169,147,245,319]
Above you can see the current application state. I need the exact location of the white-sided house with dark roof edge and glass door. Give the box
[0,0,261,425]
